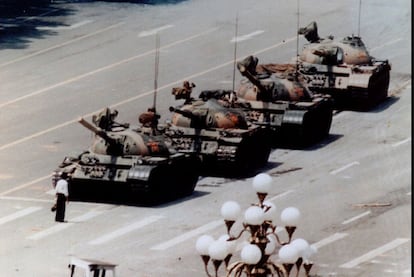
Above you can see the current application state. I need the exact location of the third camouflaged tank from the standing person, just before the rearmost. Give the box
[232,56,333,148]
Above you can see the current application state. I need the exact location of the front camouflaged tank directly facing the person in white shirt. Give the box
[53,108,200,204]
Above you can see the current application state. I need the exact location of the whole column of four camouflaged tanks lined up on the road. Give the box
[53,22,391,203]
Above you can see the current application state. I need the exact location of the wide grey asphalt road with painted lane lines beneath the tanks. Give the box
[0,0,411,277]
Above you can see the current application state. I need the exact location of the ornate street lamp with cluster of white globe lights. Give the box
[196,173,316,277]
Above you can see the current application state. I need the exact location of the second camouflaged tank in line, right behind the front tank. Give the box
[167,94,271,176]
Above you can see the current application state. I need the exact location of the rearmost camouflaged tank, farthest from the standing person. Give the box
[298,22,391,110]
